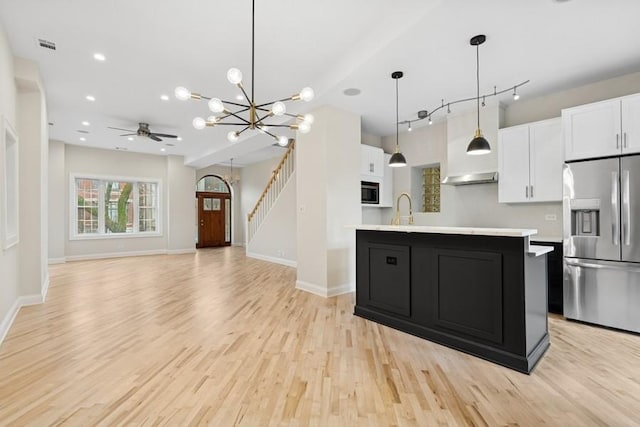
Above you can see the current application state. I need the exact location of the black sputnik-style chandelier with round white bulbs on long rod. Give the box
[175,0,314,146]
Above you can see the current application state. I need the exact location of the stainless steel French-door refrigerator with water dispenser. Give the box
[563,155,640,332]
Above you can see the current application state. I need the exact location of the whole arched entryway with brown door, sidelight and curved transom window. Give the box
[196,175,231,248]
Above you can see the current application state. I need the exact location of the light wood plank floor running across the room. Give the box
[0,248,640,426]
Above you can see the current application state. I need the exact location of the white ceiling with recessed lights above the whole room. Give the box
[0,0,640,167]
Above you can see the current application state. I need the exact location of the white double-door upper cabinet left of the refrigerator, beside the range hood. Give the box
[498,118,563,203]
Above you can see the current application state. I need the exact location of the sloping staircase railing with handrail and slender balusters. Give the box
[247,142,295,243]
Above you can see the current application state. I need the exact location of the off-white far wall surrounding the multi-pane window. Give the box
[49,145,196,262]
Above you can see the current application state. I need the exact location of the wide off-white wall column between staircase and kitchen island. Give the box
[296,106,362,296]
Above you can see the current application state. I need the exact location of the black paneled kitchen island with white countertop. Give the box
[354,225,553,373]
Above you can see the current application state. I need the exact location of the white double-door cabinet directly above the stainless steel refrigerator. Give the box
[562,94,640,160]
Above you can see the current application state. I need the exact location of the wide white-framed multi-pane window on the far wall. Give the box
[71,175,161,239]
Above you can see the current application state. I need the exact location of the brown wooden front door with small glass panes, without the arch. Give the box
[196,192,231,248]
